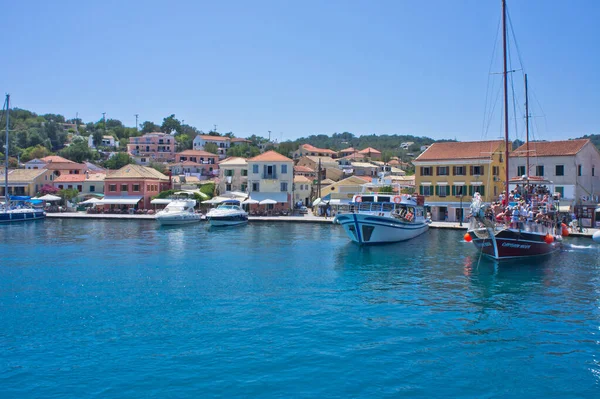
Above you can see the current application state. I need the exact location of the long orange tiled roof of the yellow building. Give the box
[415,140,504,162]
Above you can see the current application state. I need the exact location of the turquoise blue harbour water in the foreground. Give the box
[0,220,600,398]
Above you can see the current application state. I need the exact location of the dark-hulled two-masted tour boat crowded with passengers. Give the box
[465,0,561,260]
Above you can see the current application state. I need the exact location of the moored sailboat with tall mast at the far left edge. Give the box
[0,94,46,223]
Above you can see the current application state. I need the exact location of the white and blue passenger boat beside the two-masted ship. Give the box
[333,193,431,244]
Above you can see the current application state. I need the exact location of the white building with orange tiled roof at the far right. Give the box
[509,139,600,204]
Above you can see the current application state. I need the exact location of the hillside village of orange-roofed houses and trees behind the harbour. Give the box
[0,109,600,227]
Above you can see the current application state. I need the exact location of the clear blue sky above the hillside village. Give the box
[0,0,600,140]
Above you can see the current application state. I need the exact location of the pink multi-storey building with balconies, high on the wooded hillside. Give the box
[127,132,176,165]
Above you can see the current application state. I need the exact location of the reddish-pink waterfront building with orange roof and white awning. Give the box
[100,164,171,209]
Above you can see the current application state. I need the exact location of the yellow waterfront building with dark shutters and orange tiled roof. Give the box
[413,140,510,222]
